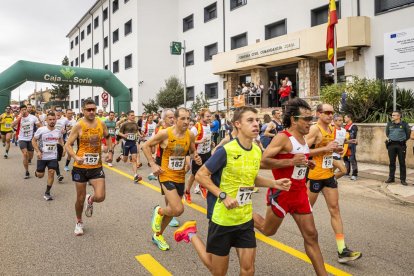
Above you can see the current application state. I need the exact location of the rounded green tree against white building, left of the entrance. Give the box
[157,76,184,108]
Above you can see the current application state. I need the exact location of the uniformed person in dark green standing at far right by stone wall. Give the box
[385,111,411,186]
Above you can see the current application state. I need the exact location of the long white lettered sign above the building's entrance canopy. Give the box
[236,38,300,62]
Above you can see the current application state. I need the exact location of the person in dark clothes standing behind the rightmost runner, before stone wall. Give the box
[344,114,358,180]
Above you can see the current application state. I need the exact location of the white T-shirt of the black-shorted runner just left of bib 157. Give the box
[34,126,62,160]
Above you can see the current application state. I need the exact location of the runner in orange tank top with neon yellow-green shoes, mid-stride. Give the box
[142,108,201,251]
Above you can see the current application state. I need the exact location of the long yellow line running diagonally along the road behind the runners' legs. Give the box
[103,165,352,276]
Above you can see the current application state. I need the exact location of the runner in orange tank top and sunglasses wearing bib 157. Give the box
[65,99,113,236]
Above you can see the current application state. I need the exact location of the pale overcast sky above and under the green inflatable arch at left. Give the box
[0,0,96,100]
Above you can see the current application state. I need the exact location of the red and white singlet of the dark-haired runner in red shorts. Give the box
[272,130,309,191]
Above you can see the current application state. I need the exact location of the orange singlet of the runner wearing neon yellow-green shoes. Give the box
[159,127,190,184]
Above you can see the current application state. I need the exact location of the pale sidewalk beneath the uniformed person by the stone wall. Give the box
[358,162,414,205]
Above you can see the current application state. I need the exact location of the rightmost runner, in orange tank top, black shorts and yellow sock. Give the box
[306,104,362,263]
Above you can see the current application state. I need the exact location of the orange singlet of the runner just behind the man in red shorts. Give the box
[308,124,335,180]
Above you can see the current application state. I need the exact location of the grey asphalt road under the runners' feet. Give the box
[0,146,414,275]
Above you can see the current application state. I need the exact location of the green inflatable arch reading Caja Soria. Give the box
[0,60,131,113]
